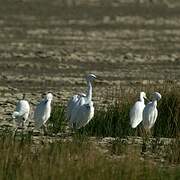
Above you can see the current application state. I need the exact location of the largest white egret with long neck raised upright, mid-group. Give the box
[67,74,96,129]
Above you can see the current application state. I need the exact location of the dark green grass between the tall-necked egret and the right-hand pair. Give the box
[83,102,133,137]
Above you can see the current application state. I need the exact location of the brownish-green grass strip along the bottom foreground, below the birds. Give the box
[0,136,180,180]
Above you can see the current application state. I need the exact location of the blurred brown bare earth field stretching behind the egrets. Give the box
[0,0,180,120]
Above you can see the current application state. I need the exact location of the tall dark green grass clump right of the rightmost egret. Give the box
[153,89,180,137]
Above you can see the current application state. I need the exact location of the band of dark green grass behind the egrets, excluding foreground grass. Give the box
[50,84,180,137]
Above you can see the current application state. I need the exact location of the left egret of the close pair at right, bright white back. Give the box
[130,92,147,128]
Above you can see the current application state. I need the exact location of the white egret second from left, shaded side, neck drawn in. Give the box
[34,93,53,132]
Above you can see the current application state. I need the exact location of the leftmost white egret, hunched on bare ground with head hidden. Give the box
[12,94,30,127]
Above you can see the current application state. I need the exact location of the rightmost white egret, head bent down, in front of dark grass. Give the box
[143,92,161,130]
